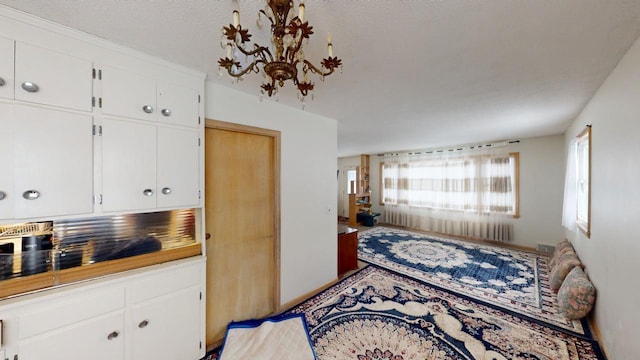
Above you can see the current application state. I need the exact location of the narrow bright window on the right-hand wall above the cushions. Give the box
[575,126,591,237]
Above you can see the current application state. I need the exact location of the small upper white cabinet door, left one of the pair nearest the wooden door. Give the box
[102,66,158,121]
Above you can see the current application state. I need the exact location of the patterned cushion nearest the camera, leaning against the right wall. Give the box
[558,266,596,320]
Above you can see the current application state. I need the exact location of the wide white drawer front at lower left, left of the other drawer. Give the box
[18,286,125,339]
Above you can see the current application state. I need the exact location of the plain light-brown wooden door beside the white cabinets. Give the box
[205,120,280,347]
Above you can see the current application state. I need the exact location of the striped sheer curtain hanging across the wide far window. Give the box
[382,149,516,241]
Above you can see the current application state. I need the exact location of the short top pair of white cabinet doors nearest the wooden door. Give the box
[101,66,200,127]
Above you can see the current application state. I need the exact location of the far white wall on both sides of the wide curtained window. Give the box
[370,135,564,248]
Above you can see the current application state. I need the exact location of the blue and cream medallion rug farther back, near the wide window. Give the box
[358,226,590,335]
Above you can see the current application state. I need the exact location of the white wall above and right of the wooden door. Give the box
[206,82,337,303]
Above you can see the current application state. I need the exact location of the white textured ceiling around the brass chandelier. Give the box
[0,0,640,156]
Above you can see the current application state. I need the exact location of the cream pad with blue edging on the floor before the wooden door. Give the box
[219,314,316,360]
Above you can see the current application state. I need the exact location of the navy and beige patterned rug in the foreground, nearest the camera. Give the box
[289,265,604,360]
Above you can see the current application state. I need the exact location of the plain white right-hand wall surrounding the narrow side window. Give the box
[565,32,640,360]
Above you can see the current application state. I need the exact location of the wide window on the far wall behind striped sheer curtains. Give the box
[380,153,519,217]
